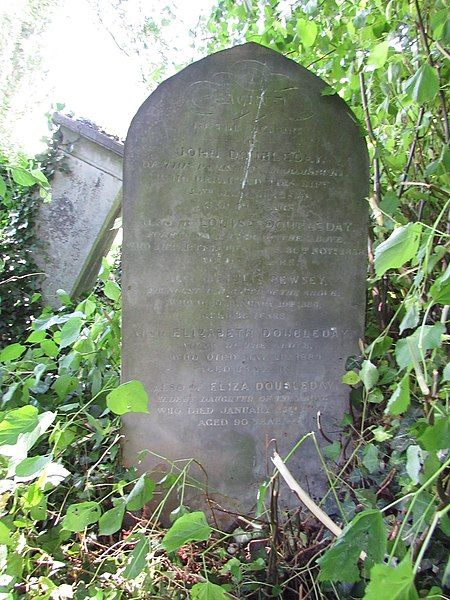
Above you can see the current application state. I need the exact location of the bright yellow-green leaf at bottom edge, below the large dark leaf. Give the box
[364,555,419,600]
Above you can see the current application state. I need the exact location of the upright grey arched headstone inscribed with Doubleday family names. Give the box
[123,44,368,513]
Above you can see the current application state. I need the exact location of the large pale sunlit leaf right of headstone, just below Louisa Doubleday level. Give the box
[375,223,422,277]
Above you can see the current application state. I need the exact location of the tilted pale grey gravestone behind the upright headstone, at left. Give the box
[34,114,123,307]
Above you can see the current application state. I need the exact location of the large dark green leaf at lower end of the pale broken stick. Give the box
[317,509,387,583]
